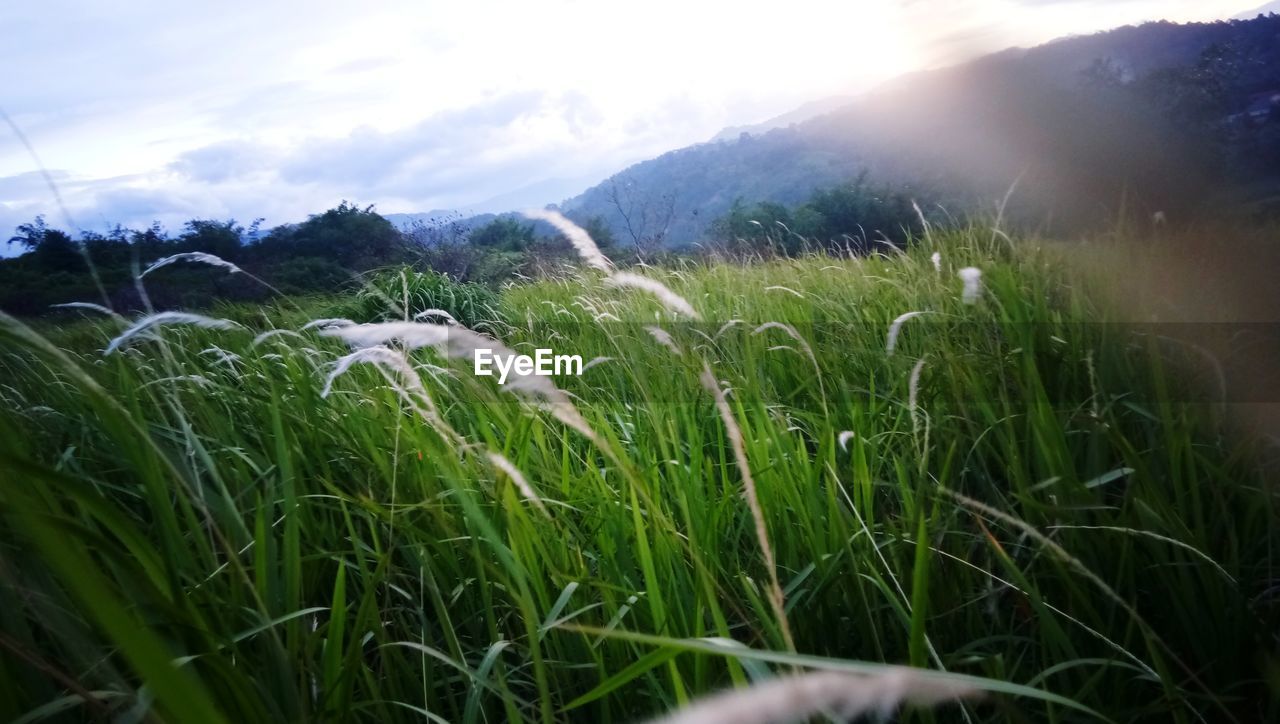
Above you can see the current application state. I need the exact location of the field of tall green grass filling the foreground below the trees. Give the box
[0,229,1280,723]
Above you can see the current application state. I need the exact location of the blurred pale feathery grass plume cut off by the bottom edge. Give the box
[654,666,978,724]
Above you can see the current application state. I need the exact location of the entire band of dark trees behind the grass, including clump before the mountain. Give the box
[0,175,920,316]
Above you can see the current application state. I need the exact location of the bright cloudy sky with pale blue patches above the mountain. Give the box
[0,0,1262,244]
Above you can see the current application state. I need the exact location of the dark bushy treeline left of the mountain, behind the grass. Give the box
[0,201,626,316]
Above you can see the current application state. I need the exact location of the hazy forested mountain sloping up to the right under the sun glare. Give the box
[562,17,1280,244]
